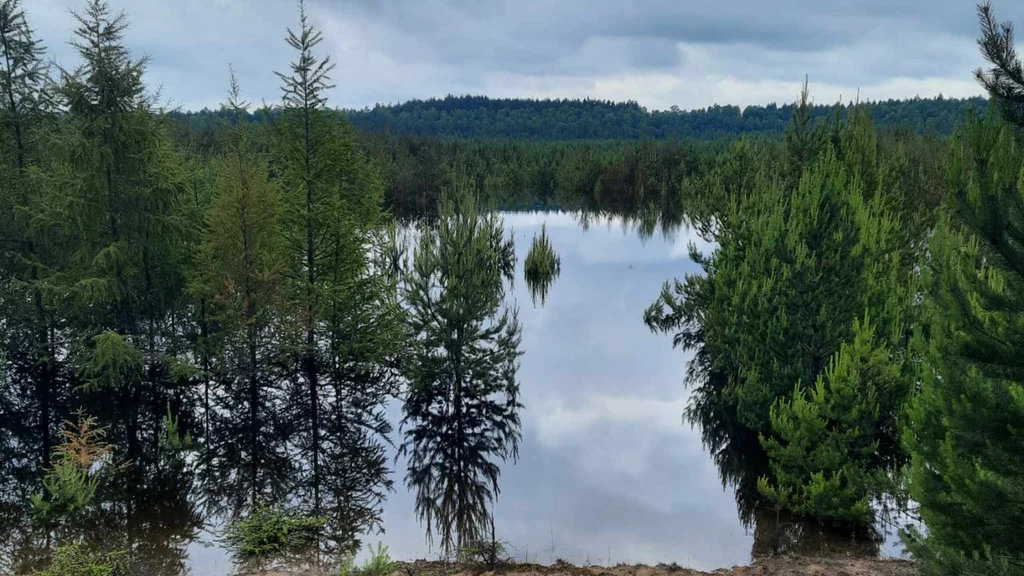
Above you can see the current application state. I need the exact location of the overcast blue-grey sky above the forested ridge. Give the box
[24,0,1024,110]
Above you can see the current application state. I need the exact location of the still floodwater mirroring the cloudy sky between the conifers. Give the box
[0,212,898,576]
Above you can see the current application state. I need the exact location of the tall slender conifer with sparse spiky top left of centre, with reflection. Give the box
[271,1,403,549]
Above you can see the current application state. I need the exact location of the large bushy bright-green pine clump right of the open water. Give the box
[645,92,913,525]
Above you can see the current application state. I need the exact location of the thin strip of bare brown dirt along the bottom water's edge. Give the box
[376,556,915,576]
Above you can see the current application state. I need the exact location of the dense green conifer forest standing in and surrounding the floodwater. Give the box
[6,0,1024,576]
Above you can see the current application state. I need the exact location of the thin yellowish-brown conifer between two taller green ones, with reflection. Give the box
[198,74,291,515]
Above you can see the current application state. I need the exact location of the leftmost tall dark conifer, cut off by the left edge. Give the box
[0,0,67,478]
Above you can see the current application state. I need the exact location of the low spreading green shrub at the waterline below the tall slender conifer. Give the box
[224,506,328,560]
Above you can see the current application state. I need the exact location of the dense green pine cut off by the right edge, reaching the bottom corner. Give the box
[904,108,1024,574]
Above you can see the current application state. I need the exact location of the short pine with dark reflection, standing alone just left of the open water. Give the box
[401,181,521,551]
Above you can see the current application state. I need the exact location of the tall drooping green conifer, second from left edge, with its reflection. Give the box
[56,0,194,470]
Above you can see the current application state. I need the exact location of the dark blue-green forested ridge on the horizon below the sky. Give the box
[174,95,986,141]
